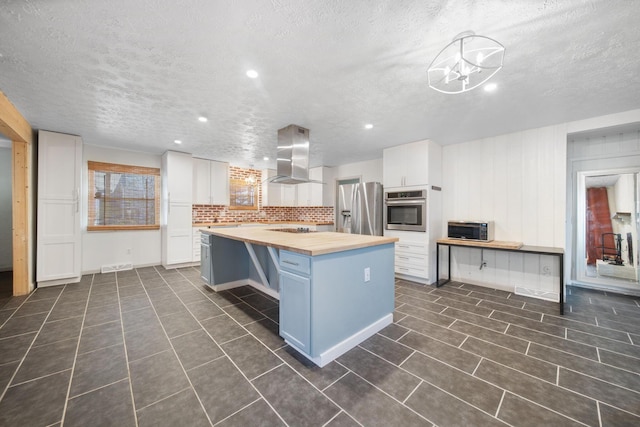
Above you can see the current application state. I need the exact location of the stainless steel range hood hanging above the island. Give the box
[269,125,320,184]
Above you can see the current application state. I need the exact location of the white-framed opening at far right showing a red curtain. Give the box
[575,169,640,291]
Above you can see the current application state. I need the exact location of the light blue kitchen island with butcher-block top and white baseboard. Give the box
[201,228,398,366]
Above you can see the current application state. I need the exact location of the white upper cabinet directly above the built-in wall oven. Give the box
[382,140,442,187]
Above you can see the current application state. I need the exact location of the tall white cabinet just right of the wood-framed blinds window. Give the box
[160,151,193,268]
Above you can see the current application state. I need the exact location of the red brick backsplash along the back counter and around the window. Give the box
[192,166,334,224]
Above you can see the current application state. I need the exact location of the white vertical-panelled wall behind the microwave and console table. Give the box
[441,125,566,295]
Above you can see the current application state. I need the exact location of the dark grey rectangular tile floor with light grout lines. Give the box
[0,267,640,426]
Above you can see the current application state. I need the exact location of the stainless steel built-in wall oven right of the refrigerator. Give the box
[384,190,427,232]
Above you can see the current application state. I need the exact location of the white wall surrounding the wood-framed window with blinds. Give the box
[82,144,161,274]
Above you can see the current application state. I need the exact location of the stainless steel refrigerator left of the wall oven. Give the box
[336,182,384,236]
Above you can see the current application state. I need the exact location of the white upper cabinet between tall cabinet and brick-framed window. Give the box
[193,158,229,206]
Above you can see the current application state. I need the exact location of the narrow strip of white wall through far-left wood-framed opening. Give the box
[0,146,13,271]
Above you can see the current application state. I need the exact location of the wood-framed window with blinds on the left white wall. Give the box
[87,161,160,231]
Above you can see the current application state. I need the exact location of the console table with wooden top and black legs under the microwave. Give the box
[436,239,564,315]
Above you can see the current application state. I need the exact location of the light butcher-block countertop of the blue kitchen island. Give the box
[200,227,399,256]
